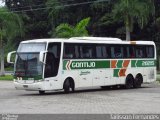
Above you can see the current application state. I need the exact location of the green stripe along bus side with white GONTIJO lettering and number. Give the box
[63,60,156,70]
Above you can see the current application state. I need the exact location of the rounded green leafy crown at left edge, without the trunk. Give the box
[0,7,24,40]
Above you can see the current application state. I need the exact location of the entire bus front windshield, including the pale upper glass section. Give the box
[15,43,46,79]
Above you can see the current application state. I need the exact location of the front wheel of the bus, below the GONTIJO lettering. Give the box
[63,78,74,93]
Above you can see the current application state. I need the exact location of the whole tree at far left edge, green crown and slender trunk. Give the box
[0,7,24,75]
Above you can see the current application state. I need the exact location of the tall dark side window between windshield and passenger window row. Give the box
[44,43,61,78]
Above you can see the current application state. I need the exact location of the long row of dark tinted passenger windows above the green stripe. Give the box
[63,43,154,59]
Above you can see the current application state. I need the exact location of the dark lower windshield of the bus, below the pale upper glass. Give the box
[15,53,43,78]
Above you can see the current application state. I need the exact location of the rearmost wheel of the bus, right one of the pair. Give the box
[133,74,143,88]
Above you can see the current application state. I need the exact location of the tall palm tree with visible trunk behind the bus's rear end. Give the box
[112,0,154,41]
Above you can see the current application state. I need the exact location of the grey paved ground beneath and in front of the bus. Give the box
[0,81,160,114]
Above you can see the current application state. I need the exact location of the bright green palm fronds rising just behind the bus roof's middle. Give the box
[53,18,90,38]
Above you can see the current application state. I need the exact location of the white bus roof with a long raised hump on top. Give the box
[21,37,155,45]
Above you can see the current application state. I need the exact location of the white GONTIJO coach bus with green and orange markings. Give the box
[7,37,156,94]
